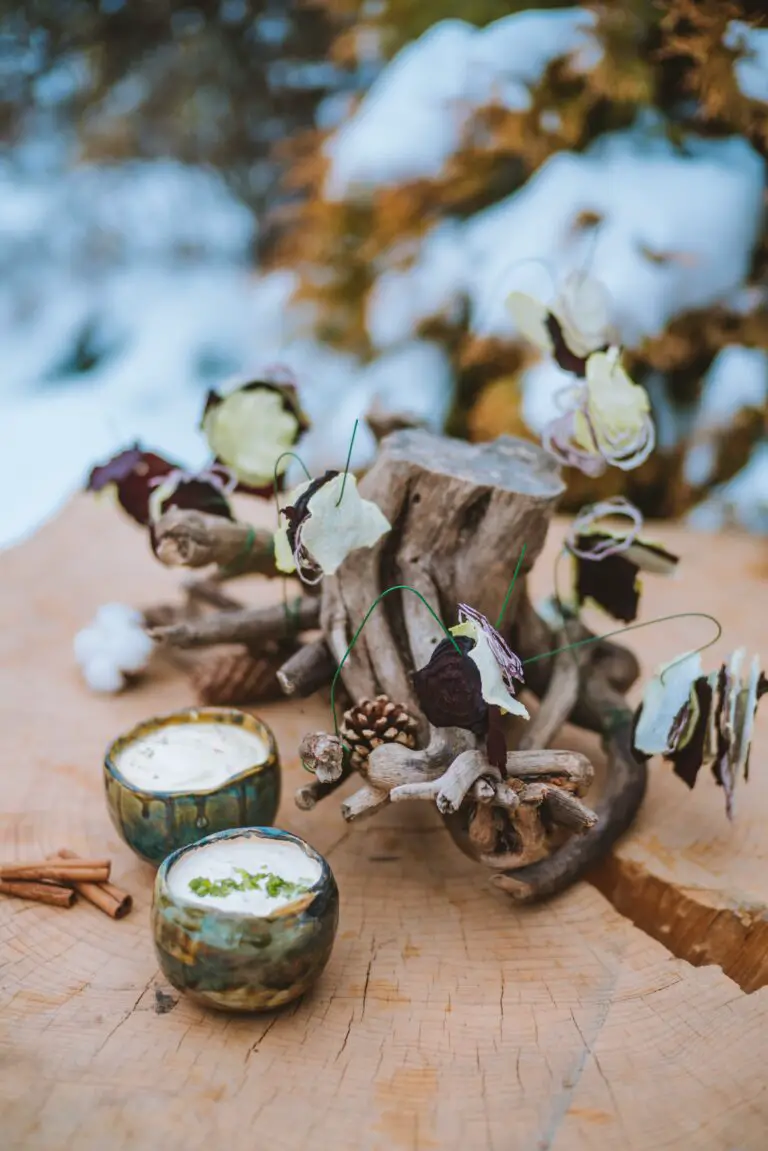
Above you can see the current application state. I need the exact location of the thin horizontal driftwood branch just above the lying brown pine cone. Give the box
[149,597,320,648]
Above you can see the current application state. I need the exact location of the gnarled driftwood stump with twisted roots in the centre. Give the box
[291,430,645,900]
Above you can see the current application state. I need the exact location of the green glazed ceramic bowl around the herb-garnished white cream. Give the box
[152,828,339,1012]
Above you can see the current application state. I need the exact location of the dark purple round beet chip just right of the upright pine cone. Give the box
[413,635,488,735]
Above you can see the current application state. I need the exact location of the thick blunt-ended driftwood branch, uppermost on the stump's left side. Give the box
[153,508,280,576]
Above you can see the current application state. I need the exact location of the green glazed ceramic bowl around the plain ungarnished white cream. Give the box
[104,708,280,866]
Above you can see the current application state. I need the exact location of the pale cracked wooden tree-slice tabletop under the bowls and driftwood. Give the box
[0,500,768,1151]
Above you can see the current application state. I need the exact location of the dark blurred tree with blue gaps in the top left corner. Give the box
[0,0,343,215]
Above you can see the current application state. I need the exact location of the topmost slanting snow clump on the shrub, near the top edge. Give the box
[325,8,600,199]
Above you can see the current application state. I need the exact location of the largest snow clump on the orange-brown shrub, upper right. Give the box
[367,120,765,348]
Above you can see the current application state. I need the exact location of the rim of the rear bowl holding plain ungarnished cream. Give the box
[104,707,280,800]
